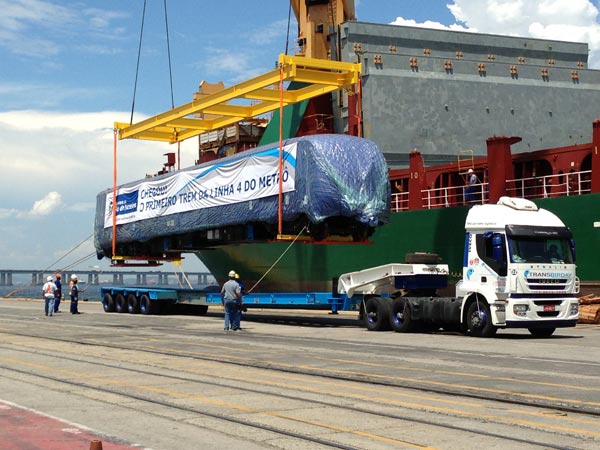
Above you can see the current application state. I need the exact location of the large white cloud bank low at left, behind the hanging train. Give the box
[0,110,198,268]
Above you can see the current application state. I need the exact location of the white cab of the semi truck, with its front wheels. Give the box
[456,197,579,337]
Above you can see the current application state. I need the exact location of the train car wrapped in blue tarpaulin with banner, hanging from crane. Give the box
[94,134,390,256]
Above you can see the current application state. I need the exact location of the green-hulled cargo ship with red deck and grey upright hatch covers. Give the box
[94,0,600,291]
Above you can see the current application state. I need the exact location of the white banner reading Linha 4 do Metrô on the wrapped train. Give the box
[104,143,297,227]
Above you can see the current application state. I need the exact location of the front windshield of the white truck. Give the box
[508,236,574,264]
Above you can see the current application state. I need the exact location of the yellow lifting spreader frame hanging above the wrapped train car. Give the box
[115,54,361,144]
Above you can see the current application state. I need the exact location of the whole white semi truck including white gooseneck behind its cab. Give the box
[338,197,579,337]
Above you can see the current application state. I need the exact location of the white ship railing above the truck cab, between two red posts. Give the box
[507,170,592,199]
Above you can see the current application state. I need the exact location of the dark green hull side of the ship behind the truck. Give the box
[196,194,600,292]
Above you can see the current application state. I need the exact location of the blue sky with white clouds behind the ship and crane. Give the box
[0,0,600,271]
